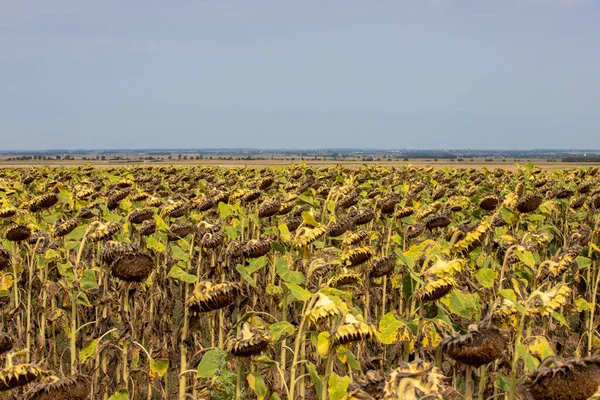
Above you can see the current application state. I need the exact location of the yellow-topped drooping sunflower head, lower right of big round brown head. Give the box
[187,281,242,313]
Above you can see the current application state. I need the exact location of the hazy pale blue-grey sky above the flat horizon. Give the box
[0,0,600,150]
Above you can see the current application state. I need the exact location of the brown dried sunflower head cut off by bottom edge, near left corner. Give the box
[22,375,92,400]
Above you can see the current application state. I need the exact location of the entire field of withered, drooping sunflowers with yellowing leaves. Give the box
[0,163,600,400]
